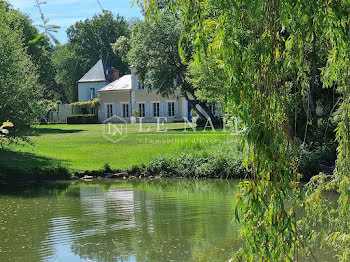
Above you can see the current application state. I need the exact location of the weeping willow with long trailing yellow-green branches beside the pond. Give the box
[144,0,350,261]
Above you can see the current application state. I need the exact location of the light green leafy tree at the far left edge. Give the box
[0,2,42,136]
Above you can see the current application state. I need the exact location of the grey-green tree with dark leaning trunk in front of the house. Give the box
[115,15,218,122]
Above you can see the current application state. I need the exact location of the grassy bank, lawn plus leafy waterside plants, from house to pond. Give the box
[0,123,245,180]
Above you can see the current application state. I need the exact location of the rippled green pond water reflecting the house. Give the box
[0,179,242,262]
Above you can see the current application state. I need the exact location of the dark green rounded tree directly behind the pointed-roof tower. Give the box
[53,10,129,102]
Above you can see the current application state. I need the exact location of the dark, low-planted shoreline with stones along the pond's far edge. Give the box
[0,158,333,184]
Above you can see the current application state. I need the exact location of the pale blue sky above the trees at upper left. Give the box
[8,0,142,44]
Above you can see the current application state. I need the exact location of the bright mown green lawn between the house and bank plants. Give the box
[0,123,235,174]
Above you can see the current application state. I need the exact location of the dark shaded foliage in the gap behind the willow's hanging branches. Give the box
[289,89,337,181]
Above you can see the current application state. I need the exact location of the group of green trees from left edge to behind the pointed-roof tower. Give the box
[0,0,130,137]
